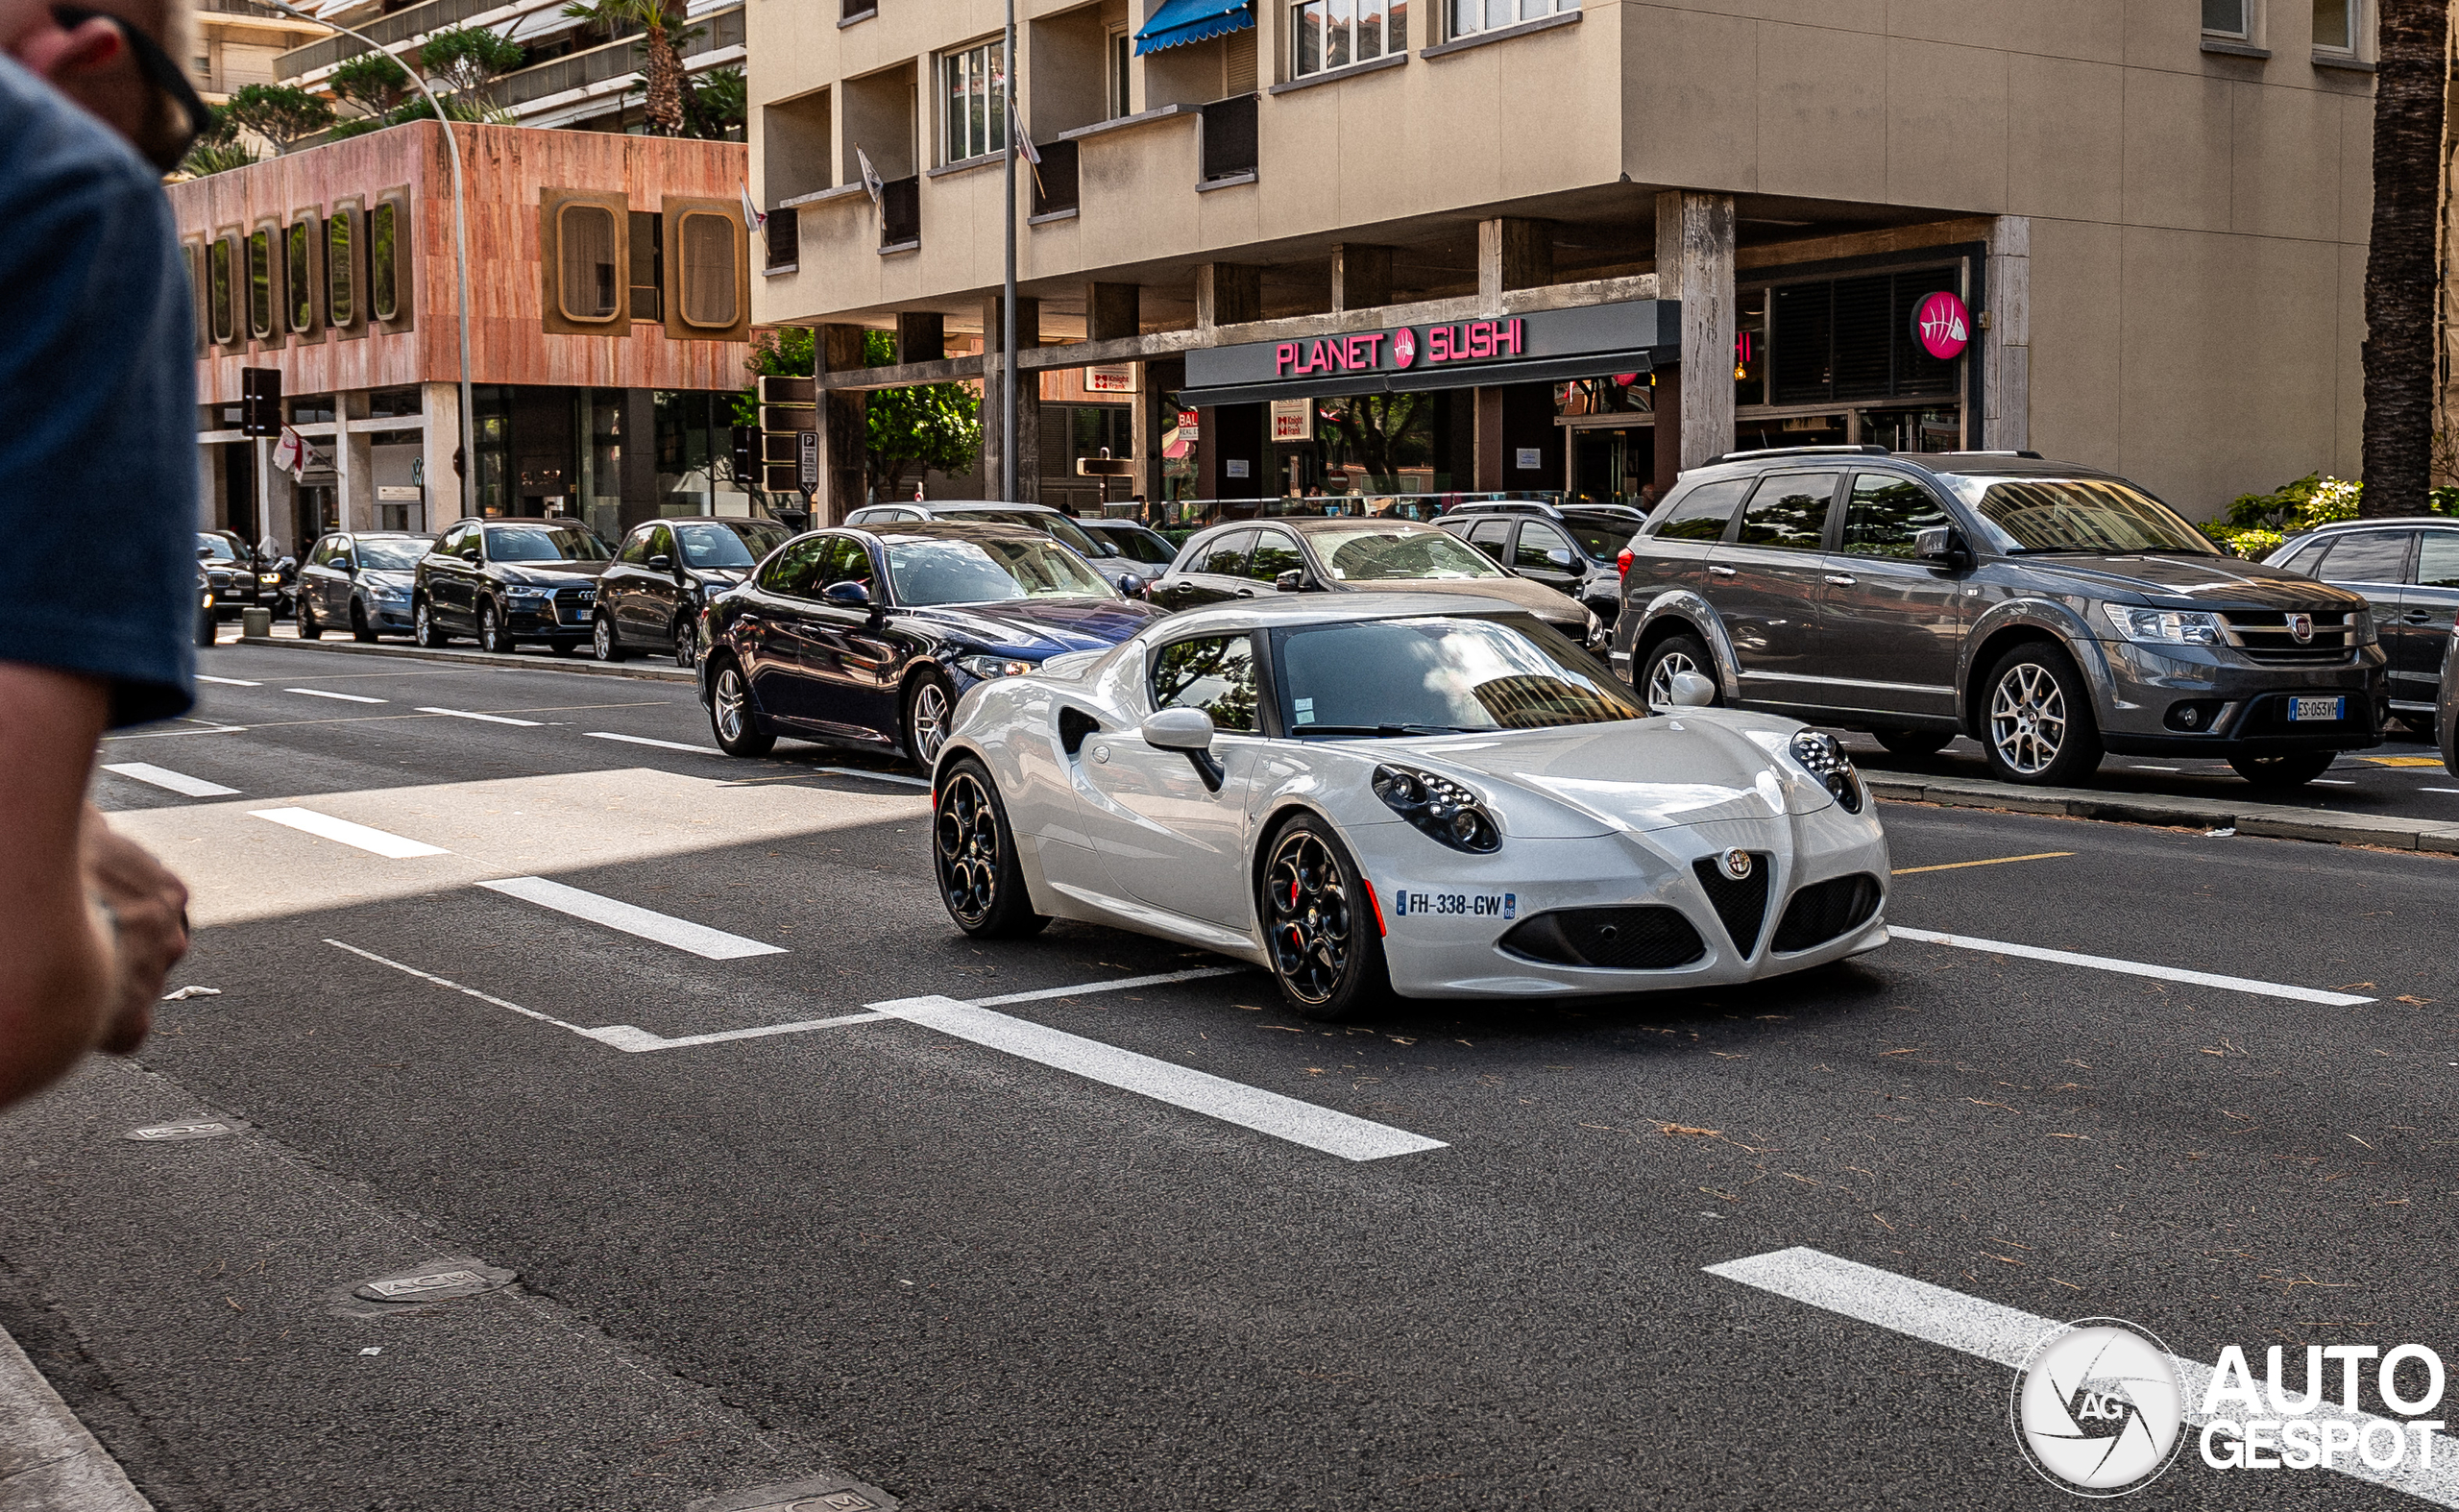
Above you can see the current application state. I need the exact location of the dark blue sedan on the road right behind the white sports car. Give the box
[701,522,1163,768]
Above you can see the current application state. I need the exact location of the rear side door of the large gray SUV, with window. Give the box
[1704,467,1844,708]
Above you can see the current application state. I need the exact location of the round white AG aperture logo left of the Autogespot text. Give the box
[2009,1318,2183,1498]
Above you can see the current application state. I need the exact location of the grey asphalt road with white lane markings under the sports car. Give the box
[0,646,2459,1512]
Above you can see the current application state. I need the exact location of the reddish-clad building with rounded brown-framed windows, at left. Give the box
[170,120,752,550]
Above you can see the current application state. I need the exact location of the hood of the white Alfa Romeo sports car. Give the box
[1372,711,1835,839]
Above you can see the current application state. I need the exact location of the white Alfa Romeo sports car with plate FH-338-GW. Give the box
[932,593,1888,1020]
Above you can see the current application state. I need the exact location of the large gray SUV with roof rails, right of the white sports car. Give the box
[1611,448,2388,787]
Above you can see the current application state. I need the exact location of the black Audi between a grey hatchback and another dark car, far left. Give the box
[411,519,615,651]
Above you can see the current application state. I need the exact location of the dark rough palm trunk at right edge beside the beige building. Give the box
[2358,0,2449,516]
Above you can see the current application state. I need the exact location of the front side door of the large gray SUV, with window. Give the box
[1813,472,1980,718]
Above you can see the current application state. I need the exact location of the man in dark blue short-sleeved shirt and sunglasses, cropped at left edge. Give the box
[0,0,197,1104]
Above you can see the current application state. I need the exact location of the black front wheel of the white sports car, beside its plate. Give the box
[1256,814,1392,1023]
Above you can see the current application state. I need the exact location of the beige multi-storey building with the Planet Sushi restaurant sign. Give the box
[747,0,2373,516]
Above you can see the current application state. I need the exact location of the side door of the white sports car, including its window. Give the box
[1080,632,1264,935]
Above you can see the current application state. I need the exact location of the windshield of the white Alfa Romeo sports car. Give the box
[1277,615,1645,735]
